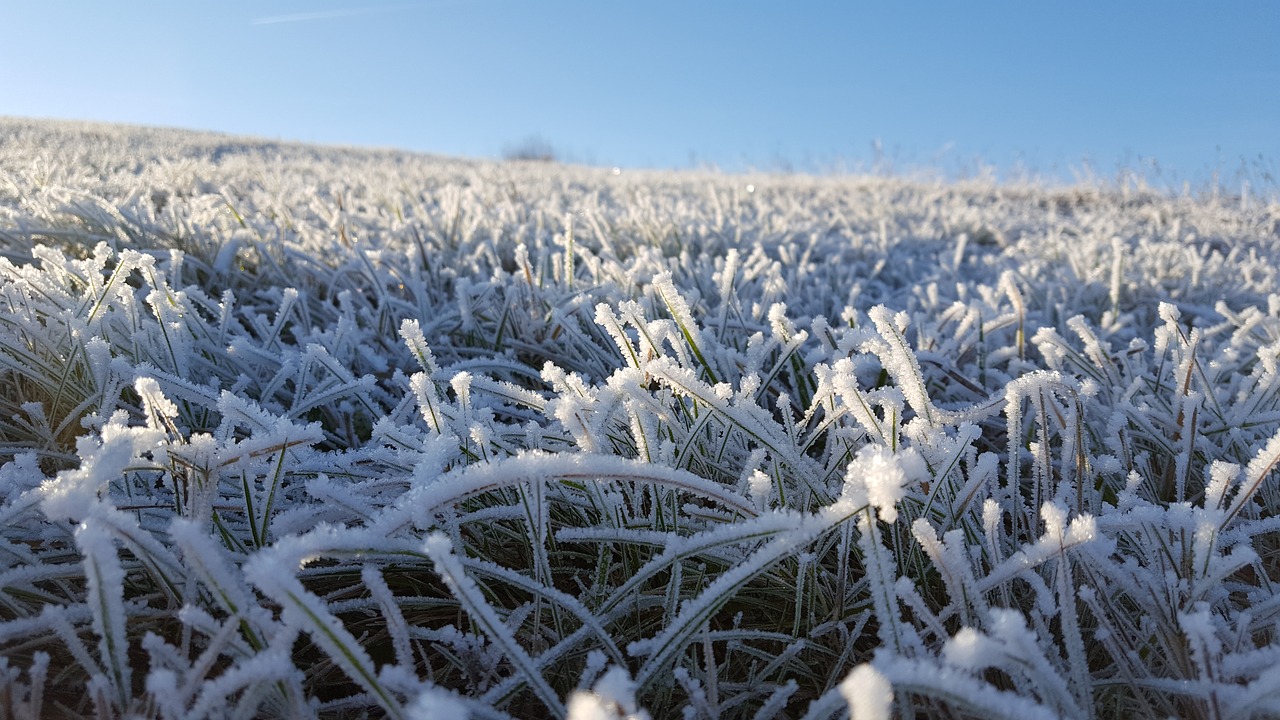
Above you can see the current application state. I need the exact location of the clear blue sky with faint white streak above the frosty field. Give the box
[0,0,1280,183]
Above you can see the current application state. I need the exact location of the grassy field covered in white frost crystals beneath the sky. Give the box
[0,119,1280,720]
